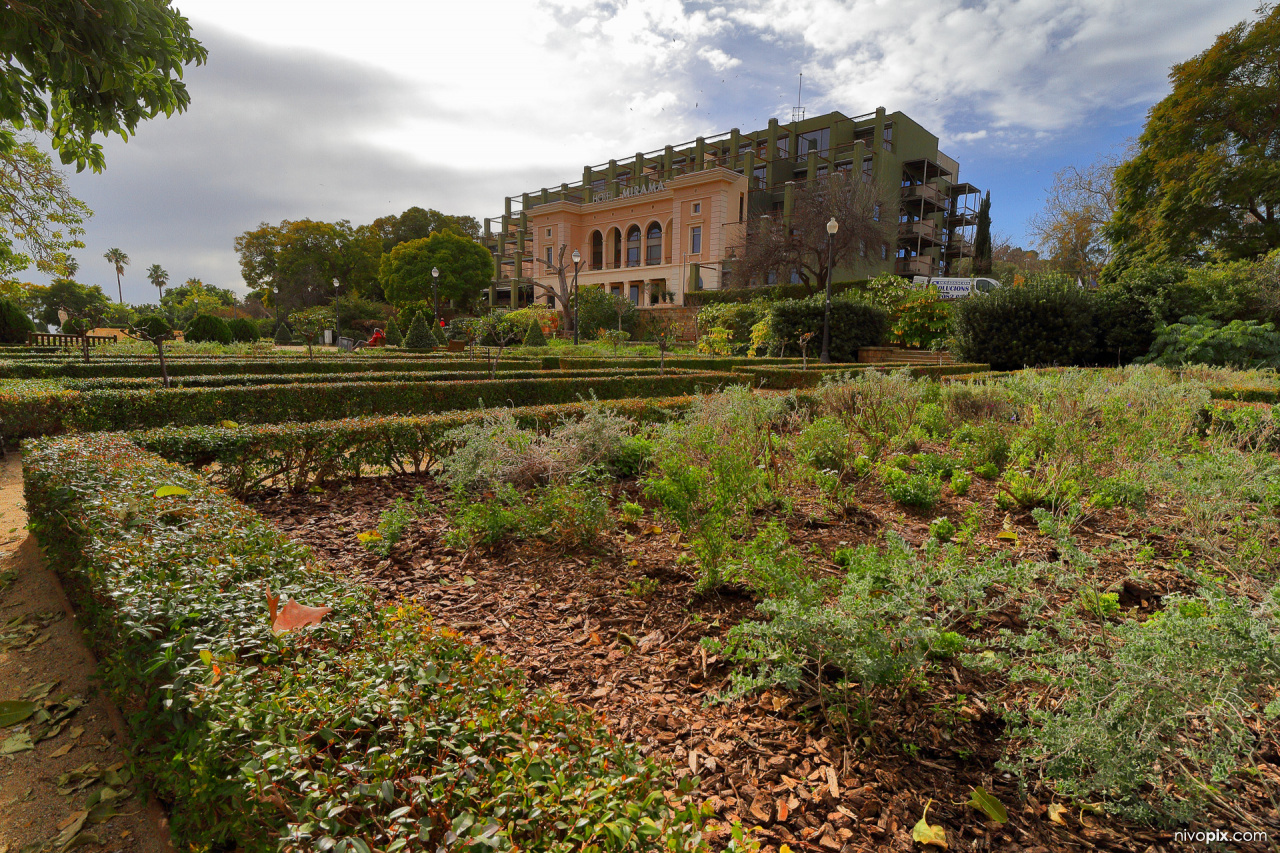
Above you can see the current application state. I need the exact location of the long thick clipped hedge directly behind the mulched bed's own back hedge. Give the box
[0,373,732,441]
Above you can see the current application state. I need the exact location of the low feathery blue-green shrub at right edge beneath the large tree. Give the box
[1138,316,1280,370]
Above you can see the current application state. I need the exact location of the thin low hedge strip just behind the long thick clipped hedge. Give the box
[60,366,689,391]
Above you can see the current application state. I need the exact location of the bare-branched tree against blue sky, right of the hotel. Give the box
[1029,156,1120,279]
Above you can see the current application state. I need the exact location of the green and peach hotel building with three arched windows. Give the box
[484,108,978,307]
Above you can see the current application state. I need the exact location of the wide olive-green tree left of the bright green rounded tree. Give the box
[236,219,381,313]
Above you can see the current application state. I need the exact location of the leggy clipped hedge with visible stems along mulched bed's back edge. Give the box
[131,396,692,494]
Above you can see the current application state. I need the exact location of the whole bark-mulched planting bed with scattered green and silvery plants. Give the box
[240,368,1280,850]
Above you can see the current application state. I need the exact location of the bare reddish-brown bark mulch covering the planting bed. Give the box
[255,475,1280,853]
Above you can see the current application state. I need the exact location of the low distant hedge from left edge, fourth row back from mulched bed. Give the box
[0,357,538,379]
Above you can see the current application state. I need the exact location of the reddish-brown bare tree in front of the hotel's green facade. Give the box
[733,172,891,295]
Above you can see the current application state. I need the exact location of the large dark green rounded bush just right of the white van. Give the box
[951,278,1097,370]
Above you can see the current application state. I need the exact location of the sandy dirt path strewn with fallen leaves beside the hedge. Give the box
[0,452,172,853]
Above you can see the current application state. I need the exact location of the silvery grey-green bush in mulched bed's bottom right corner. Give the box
[1018,589,1280,825]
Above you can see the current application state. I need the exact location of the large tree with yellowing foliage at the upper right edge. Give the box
[1107,5,1280,268]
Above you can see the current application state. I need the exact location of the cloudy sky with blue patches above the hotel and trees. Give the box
[37,0,1257,304]
